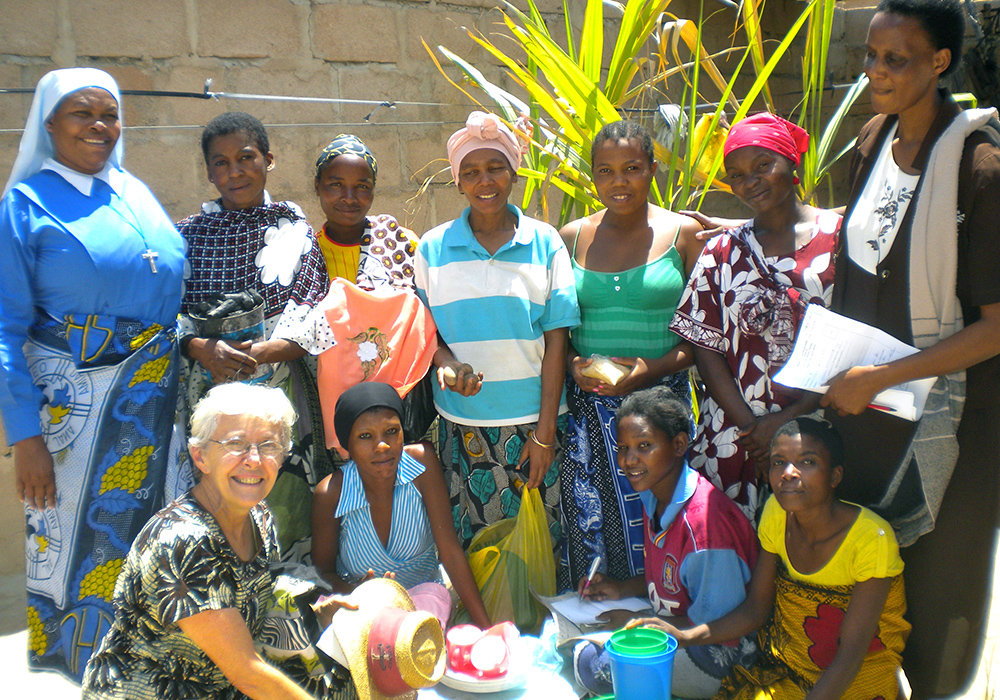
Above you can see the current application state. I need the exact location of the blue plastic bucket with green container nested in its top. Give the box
[604,630,677,700]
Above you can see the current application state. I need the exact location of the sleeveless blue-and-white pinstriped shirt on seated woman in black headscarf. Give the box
[335,452,441,588]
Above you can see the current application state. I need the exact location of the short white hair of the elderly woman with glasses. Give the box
[188,382,297,452]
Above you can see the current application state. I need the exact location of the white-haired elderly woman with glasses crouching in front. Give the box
[83,383,352,700]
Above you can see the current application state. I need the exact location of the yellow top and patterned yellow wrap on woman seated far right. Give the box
[715,496,910,700]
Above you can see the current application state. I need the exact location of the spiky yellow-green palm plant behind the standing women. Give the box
[425,0,860,224]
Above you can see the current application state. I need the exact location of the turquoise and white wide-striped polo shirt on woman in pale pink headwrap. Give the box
[415,204,580,426]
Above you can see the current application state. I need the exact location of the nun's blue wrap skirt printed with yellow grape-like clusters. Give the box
[24,315,192,683]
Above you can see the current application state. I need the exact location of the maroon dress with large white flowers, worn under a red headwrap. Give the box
[670,211,841,521]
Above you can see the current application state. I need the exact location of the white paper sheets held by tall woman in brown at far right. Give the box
[774,304,936,421]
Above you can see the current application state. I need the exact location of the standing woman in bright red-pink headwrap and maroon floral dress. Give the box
[670,113,841,519]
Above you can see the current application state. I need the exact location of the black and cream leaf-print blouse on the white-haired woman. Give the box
[83,492,278,700]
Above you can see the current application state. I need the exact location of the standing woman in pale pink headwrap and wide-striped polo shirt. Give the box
[416,112,580,547]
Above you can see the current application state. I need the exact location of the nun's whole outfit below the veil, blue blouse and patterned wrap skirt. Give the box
[0,160,187,682]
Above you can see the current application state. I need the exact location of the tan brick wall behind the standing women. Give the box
[0,0,888,574]
